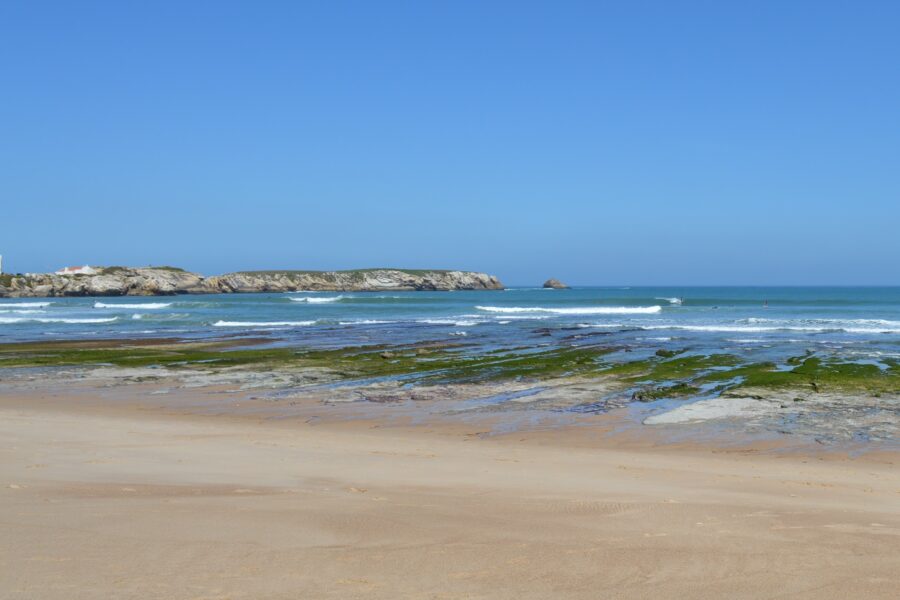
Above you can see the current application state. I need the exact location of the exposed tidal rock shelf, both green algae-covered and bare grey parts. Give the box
[0,336,900,454]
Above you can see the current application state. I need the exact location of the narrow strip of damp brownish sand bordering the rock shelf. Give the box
[7,376,900,464]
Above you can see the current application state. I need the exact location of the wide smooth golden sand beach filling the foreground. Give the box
[0,392,900,600]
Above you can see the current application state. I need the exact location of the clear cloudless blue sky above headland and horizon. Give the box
[0,0,900,285]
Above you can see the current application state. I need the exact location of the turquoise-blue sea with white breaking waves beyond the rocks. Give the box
[0,287,900,360]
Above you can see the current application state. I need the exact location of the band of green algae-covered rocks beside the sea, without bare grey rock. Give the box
[0,338,900,401]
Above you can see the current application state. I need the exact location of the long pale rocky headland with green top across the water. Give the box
[0,267,504,298]
